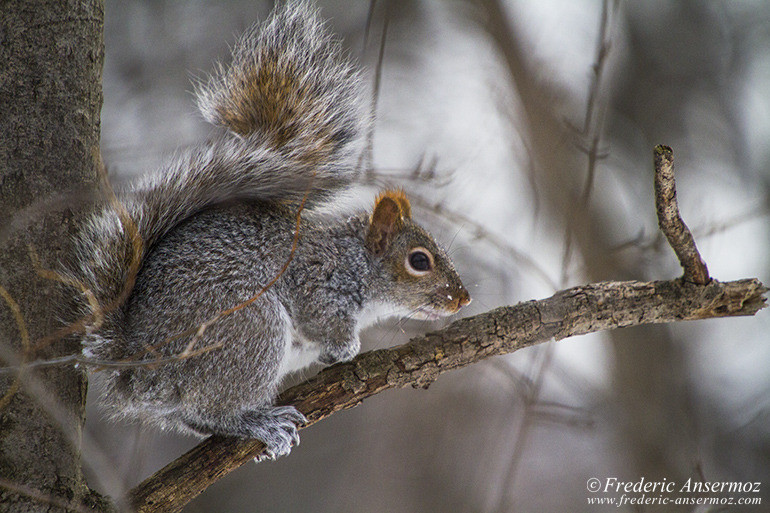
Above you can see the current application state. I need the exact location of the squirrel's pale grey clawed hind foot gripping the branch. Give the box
[241,406,307,461]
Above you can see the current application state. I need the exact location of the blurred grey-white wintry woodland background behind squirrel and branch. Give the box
[85,0,770,513]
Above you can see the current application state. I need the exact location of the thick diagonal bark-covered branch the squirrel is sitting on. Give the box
[130,279,768,513]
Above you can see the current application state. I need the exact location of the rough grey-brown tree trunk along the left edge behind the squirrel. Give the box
[0,0,104,512]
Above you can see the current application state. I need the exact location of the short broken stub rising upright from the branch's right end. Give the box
[655,145,711,285]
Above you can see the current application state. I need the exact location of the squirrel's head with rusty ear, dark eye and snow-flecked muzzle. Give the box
[365,191,471,320]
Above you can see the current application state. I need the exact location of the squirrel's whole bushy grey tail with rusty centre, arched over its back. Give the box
[67,1,369,337]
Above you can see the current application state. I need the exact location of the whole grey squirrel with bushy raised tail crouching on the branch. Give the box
[71,0,470,458]
